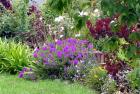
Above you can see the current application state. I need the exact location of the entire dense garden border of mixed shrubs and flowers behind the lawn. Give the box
[0,0,140,94]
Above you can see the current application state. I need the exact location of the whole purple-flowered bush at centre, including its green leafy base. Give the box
[20,38,95,80]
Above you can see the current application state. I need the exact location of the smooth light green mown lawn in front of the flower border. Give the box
[0,74,96,94]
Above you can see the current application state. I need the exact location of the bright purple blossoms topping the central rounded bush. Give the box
[33,38,93,65]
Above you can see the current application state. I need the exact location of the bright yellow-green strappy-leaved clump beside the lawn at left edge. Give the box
[0,39,31,74]
